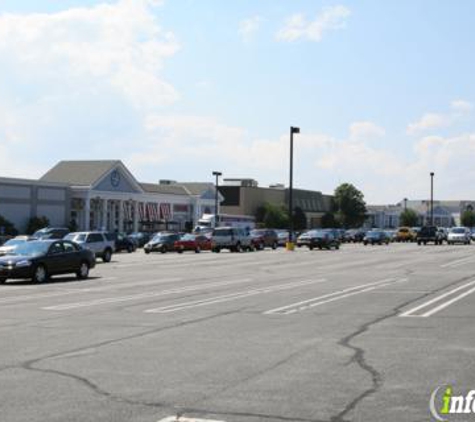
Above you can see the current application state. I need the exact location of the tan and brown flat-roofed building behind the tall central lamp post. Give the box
[219,179,332,227]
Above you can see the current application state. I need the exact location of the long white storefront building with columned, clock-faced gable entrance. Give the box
[0,160,223,232]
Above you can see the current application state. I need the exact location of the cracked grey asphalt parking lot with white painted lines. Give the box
[0,243,475,422]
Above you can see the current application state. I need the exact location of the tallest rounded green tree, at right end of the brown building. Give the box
[334,183,366,228]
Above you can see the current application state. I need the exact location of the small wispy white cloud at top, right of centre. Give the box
[276,5,351,42]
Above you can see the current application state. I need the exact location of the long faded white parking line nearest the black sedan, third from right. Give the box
[42,278,252,311]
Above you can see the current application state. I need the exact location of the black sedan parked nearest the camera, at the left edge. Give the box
[0,240,96,283]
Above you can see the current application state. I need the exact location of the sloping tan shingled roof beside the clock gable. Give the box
[40,160,120,186]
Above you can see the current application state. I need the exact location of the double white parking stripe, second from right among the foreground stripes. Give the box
[264,278,407,315]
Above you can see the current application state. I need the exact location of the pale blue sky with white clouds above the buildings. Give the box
[0,0,475,204]
